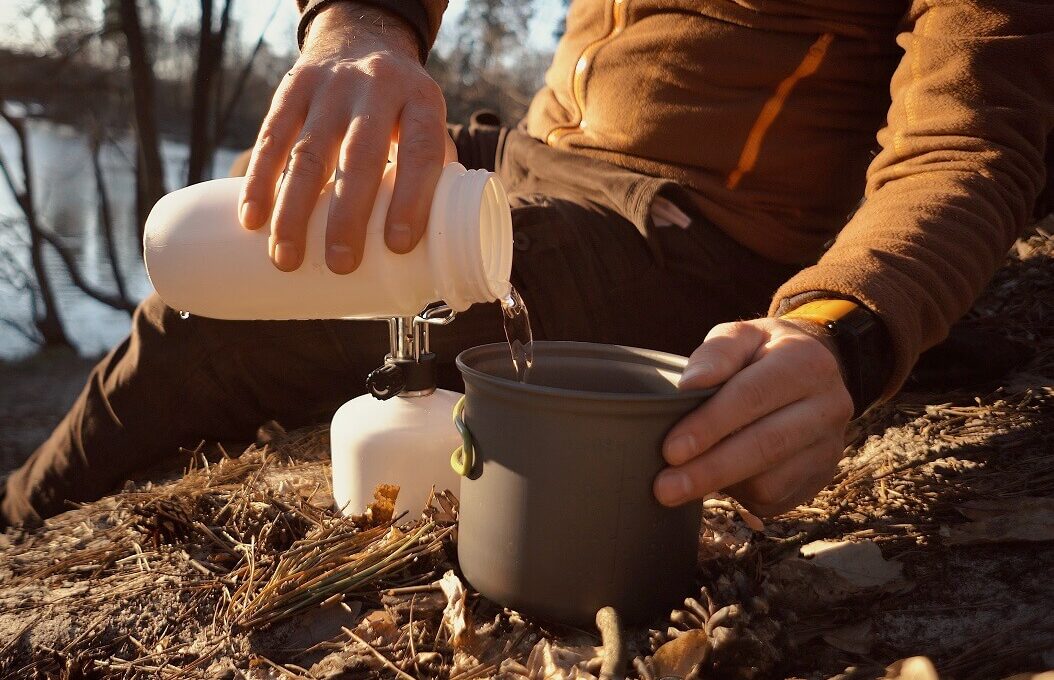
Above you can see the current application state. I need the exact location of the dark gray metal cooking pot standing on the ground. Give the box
[452,342,713,625]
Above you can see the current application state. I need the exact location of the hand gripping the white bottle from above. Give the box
[238,2,456,274]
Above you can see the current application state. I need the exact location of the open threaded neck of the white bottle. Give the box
[429,163,512,311]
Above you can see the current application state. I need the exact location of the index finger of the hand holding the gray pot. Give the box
[663,335,841,465]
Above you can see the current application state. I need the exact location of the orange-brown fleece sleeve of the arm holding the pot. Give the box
[770,0,1054,396]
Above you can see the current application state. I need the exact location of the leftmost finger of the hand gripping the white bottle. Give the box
[238,71,310,229]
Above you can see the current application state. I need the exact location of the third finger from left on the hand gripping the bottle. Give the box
[326,106,395,274]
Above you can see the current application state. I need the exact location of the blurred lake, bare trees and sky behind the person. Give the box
[0,0,568,465]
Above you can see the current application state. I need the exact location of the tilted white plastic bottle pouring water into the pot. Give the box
[143,162,512,319]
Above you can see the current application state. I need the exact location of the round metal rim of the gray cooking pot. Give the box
[454,341,718,403]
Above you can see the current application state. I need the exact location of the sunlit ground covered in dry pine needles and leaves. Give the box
[0,228,1054,680]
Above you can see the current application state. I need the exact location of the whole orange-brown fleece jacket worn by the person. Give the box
[298,0,1054,395]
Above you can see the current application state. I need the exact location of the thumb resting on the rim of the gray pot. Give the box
[678,322,768,390]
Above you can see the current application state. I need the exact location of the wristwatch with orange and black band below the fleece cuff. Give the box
[780,299,893,419]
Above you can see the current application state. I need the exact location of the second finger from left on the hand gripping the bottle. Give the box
[269,104,347,272]
